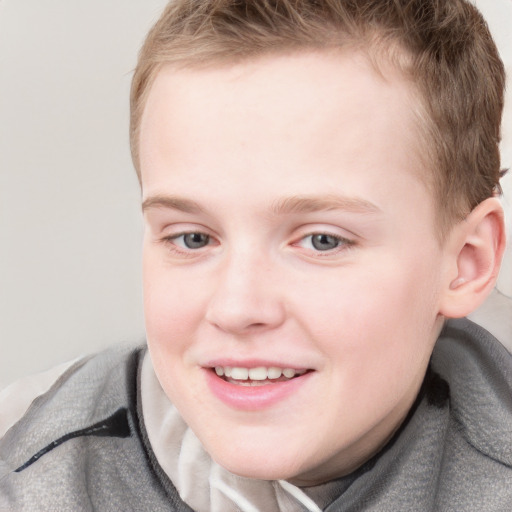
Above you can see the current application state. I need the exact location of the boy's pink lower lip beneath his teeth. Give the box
[204,369,313,411]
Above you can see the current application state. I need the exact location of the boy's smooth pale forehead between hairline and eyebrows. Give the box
[140,51,430,216]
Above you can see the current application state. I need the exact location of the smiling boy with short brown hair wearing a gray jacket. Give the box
[0,0,512,511]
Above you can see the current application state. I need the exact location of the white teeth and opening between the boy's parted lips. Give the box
[214,366,311,386]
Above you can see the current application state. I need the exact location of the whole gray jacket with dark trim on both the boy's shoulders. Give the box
[0,320,512,512]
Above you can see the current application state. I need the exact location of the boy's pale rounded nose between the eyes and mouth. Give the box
[206,250,285,335]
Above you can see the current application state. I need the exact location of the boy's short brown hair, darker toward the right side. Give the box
[130,0,505,231]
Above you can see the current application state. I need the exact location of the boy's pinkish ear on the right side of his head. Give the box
[439,198,505,318]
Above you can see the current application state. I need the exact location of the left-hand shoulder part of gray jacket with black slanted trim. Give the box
[0,350,190,512]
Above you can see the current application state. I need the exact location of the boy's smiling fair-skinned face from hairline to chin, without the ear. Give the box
[140,53,450,485]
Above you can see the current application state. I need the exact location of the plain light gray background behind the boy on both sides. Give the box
[0,0,512,388]
